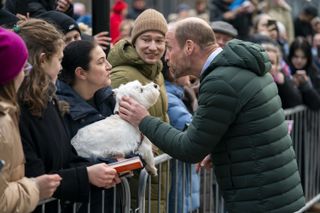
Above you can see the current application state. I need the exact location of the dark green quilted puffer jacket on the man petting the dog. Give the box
[140,40,305,213]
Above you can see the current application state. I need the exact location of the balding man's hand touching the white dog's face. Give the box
[119,97,149,127]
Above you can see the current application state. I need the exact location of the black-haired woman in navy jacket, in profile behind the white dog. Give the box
[57,41,115,137]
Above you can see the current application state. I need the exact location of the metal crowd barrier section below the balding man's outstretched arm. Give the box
[132,154,225,213]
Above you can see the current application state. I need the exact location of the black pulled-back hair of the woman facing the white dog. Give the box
[59,40,97,86]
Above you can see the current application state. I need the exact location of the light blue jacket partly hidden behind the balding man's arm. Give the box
[165,81,200,213]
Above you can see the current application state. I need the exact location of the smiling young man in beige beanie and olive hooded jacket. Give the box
[108,9,168,212]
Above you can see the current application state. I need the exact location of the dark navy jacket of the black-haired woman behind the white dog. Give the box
[57,81,115,138]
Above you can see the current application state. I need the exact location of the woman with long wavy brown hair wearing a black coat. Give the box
[15,19,120,212]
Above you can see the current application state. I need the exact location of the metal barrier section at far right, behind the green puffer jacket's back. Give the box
[285,106,320,213]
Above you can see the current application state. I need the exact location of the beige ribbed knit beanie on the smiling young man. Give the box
[131,9,168,44]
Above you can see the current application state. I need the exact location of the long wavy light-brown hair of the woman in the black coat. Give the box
[17,19,64,117]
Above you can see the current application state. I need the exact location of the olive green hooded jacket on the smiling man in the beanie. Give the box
[108,40,169,213]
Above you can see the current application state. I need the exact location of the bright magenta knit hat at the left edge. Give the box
[0,27,28,85]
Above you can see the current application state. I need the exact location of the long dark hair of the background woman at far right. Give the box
[288,37,312,73]
